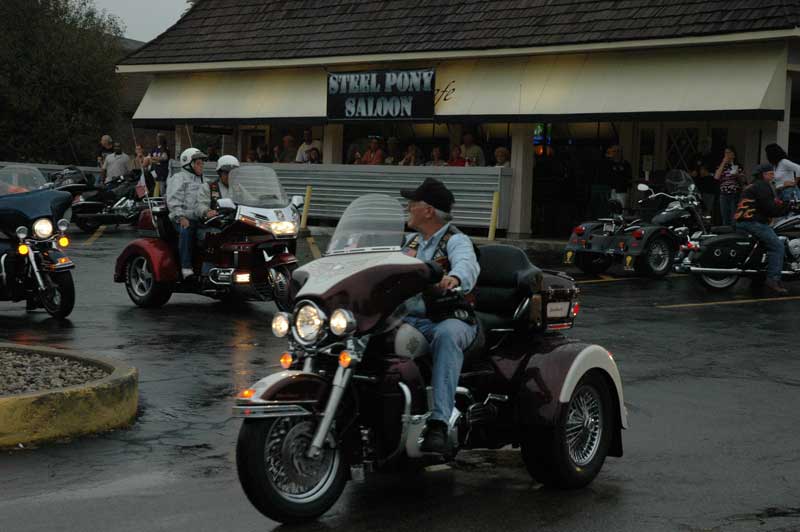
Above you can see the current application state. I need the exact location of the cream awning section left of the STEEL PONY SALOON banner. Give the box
[133,68,327,123]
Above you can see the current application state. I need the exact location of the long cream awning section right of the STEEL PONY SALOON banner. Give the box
[436,43,787,118]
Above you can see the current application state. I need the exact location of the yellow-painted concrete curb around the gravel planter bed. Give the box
[0,343,139,449]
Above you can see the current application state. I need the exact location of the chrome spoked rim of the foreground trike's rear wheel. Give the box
[564,385,605,467]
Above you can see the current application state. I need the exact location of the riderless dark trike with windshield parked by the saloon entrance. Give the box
[564,170,709,277]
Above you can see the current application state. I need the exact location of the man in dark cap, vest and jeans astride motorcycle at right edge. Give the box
[735,164,788,295]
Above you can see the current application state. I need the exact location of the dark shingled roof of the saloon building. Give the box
[121,0,800,65]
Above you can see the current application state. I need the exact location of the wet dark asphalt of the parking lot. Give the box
[0,229,800,532]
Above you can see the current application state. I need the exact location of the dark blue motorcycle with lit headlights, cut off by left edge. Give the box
[0,189,75,318]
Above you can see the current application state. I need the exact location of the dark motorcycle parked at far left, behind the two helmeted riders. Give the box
[72,172,145,233]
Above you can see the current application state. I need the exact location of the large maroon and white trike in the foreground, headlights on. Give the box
[233,194,627,523]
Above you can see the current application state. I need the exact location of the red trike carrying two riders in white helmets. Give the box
[114,166,303,310]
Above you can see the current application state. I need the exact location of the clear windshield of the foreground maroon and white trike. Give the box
[326,194,406,255]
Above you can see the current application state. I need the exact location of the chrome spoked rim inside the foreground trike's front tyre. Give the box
[264,417,339,503]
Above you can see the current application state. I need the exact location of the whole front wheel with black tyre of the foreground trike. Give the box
[236,417,347,524]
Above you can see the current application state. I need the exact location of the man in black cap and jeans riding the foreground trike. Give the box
[400,178,480,453]
